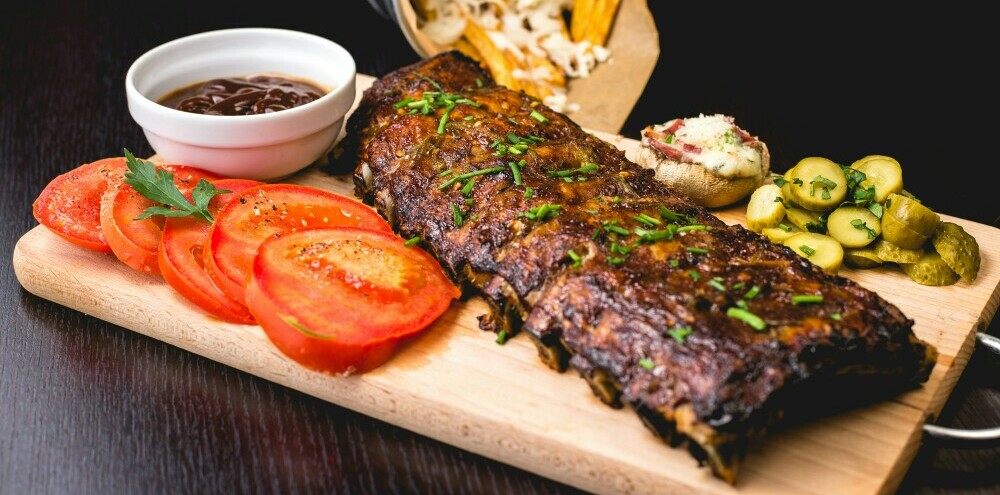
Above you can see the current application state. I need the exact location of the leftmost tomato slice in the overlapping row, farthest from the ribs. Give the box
[31,158,128,253]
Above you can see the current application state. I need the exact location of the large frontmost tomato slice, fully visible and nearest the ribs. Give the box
[247,227,459,374]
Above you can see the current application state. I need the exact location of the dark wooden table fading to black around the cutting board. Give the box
[0,0,1000,494]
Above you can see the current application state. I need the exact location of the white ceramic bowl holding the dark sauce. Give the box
[125,28,357,181]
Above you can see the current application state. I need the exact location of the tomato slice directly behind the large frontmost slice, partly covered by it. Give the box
[205,184,392,302]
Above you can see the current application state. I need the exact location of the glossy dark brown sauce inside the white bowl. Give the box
[157,75,326,115]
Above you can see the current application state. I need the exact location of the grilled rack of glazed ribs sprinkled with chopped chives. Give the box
[347,52,936,483]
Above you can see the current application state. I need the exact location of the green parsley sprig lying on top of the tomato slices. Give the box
[125,149,231,223]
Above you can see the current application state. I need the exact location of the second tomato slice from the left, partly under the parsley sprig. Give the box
[101,165,222,273]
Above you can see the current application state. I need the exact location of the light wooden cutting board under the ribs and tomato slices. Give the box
[13,76,1000,494]
